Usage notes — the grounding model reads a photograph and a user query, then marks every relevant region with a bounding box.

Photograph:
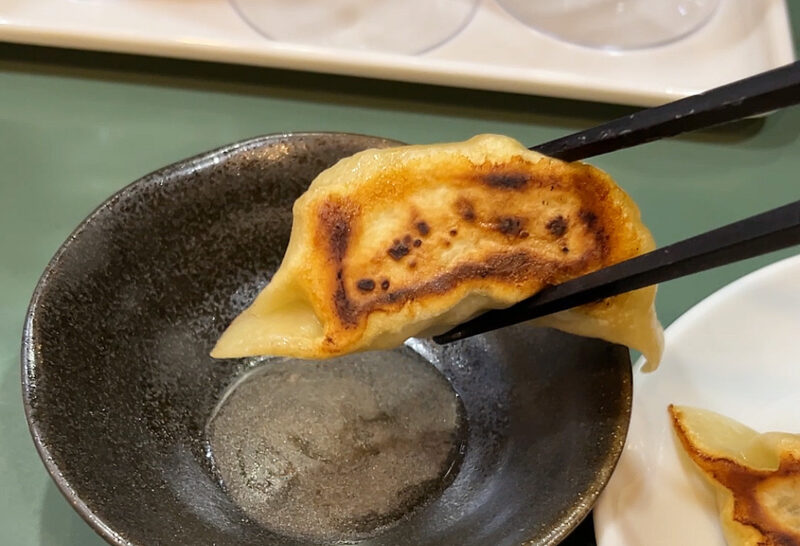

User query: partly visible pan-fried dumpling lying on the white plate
[669,405,800,546]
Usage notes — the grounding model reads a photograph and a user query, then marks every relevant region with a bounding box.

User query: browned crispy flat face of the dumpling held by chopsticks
[304,156,640,351]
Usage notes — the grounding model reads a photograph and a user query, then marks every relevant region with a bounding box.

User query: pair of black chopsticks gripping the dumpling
[433,61,800,343]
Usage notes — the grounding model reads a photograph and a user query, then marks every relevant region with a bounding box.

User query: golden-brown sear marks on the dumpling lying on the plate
[669,404,800,546]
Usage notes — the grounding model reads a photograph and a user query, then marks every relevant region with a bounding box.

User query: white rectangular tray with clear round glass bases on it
[0,0,794,106]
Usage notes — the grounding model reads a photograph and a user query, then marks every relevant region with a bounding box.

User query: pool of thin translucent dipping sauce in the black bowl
[207,350,466,541]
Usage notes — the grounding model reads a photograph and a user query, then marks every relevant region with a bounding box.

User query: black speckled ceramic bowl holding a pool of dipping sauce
[22,134,631,546]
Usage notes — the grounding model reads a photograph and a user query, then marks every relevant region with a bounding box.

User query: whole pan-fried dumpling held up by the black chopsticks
[211,135,663,367]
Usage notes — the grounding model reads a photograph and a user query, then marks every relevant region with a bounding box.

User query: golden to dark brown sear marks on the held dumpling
[317,156,627,329]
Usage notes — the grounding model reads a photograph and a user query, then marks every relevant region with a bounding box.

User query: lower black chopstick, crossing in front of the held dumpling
[433,201,800,343]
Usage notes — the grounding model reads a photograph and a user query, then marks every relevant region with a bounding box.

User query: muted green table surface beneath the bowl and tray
[0,7,800,546]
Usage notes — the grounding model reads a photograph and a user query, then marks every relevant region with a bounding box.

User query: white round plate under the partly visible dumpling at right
[594,255,800,546]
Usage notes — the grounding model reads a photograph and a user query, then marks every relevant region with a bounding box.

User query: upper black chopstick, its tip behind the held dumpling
[531,61,800,161]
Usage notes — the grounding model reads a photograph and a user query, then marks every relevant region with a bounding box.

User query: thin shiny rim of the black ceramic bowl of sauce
[20,131,633,546]
